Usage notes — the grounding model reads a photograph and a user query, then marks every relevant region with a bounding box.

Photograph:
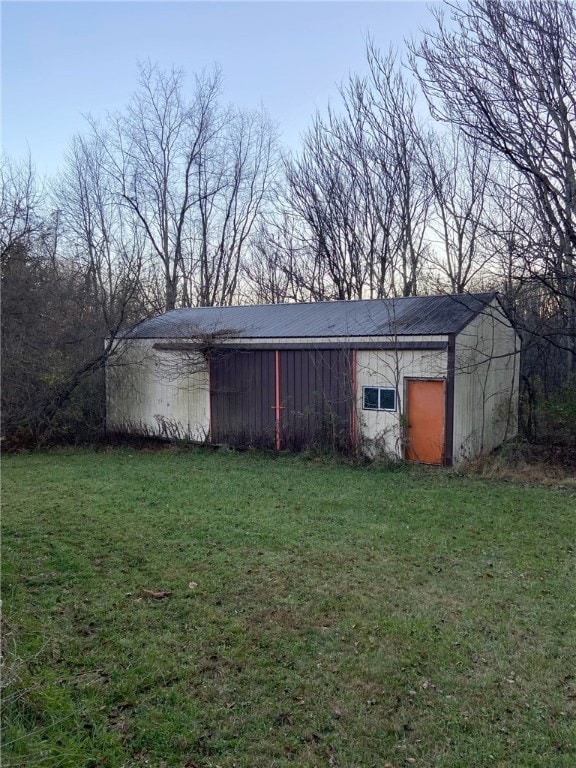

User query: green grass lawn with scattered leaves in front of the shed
[2,449,576,768]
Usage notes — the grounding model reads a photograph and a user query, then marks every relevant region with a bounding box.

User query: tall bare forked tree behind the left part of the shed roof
[103,64,222,310]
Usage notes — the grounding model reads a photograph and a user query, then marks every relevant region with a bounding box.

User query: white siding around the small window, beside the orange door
[356,346,447,459]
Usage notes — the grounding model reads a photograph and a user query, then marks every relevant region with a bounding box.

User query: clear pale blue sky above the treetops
[1,0,433,173]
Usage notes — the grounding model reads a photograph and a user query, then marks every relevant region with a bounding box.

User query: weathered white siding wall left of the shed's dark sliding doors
[106,340,210,441]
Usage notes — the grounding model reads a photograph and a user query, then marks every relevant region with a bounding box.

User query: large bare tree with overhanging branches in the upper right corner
[413,0,576,372]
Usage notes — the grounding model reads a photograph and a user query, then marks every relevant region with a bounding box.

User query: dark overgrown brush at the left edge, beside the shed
[1,247,106,450]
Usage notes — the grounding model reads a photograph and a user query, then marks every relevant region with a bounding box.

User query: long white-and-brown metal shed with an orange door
[107,293,519,465]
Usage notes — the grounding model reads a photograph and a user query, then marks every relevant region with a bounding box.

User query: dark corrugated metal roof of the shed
[127,293,496,339]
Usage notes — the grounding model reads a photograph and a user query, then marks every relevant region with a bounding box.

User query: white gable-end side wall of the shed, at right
[453,303,520,464]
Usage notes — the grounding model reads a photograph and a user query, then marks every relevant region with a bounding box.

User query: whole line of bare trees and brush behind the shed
[0,0,576,444]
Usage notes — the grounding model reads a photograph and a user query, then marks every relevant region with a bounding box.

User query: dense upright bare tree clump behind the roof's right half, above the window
[286,43,431,299]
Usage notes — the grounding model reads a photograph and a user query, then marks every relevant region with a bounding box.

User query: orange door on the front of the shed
[406,379,444,464]
